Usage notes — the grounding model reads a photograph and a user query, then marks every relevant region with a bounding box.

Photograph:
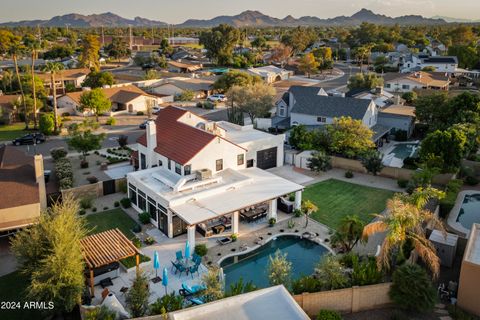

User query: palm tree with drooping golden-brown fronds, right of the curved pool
[363,192,445,277]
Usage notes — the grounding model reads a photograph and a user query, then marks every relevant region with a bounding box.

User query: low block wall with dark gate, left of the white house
[62,178,127,199]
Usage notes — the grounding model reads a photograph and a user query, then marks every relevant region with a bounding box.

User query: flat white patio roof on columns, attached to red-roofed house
[170,168,304,224]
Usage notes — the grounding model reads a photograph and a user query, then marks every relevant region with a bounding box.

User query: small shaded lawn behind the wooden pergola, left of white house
[85,208,137,239]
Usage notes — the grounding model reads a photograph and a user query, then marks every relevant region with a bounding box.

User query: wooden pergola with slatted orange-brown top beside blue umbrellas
[80,228,140,296]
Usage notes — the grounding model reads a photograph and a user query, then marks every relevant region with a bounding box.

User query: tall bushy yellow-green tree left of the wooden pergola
[12,195,86,312]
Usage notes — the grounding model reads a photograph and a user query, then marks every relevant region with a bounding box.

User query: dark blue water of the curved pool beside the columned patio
[221,236,329,291]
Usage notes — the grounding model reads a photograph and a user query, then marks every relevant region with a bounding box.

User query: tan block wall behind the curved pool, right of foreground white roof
[293,283,392,317]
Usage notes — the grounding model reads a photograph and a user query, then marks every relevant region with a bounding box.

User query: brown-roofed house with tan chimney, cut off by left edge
[0,145,47,232]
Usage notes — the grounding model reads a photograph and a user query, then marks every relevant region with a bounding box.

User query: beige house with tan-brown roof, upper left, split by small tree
[57,85,160,115]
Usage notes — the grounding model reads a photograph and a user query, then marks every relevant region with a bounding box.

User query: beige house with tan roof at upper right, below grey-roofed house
[383,71,450,92]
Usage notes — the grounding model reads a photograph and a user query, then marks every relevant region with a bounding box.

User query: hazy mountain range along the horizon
[0,9,447,28]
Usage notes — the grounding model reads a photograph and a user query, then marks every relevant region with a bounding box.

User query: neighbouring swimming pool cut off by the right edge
[448,190,480,237]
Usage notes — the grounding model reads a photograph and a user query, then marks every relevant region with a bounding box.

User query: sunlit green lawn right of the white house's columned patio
[302,179,394,229]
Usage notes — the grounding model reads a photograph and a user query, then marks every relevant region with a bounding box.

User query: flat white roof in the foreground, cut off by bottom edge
[169,286,310,320]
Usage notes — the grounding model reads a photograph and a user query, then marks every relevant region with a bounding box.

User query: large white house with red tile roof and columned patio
[127,107,303,246]
